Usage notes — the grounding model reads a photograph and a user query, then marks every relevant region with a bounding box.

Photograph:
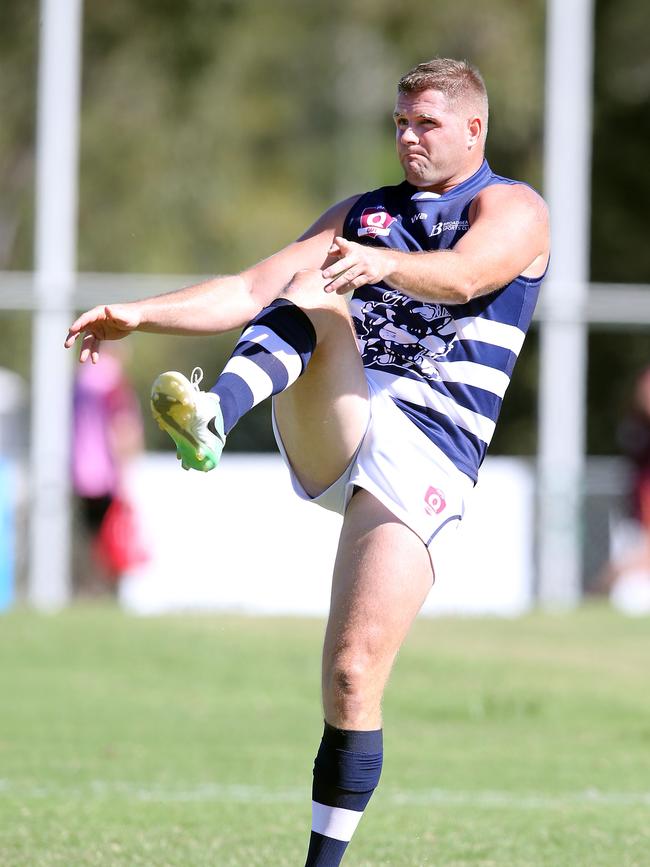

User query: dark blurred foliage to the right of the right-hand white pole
[587,0,650,454]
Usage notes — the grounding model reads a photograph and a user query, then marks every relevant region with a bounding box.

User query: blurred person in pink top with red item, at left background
[72,344,145,593]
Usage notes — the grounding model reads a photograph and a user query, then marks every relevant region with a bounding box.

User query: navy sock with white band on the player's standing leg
[305,723,383,867]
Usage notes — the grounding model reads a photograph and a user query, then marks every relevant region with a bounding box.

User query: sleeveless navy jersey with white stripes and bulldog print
[343,161,542,481]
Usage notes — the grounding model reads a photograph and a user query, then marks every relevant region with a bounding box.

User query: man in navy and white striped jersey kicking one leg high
[66,59,549,867]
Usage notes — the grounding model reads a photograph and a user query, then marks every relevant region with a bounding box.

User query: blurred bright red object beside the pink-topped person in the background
[95,497,149,581]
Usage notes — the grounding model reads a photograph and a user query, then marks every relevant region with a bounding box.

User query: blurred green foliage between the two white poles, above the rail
[79,0,543,273]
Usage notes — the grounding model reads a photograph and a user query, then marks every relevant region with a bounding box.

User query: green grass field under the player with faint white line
[0,607,650,867]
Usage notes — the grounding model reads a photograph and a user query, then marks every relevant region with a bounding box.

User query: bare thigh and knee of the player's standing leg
[323,490,433,730]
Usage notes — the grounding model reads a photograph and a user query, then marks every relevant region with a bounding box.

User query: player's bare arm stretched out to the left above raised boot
[65,197,356,363]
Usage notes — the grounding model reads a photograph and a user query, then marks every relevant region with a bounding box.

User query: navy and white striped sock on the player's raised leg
[211,298,316,433]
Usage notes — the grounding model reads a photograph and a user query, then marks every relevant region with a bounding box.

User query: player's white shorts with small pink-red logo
[273,371,474,562]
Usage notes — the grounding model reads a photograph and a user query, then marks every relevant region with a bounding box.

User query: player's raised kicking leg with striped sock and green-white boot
[151,271,369,482]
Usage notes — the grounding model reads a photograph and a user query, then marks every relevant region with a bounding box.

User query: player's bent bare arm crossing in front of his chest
[323,184,549,304]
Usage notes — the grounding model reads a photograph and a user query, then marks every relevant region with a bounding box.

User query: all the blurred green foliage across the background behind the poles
[0,0,650,453]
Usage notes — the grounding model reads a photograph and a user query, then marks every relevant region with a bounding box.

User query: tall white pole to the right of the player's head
[538,0,593,608]
